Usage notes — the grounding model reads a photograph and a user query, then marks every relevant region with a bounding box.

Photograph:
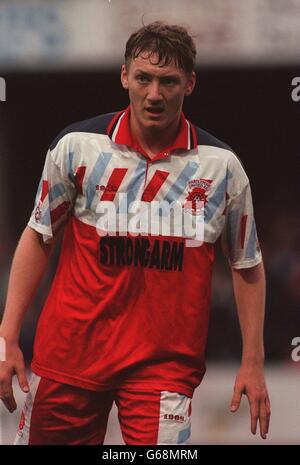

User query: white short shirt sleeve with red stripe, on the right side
[221,158,262,269]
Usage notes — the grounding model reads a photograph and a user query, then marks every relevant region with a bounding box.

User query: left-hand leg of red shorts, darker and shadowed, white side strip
[15,374,113,445]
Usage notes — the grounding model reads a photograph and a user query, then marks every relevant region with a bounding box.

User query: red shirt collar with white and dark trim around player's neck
[107,105,197,160]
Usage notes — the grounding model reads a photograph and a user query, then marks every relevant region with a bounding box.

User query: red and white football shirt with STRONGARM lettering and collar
[28,107,261,396]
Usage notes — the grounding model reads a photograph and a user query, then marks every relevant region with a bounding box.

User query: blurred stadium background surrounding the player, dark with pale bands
[0,0,300,444]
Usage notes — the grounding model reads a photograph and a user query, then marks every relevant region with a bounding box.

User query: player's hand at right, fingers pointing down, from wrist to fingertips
[230,365,271,439]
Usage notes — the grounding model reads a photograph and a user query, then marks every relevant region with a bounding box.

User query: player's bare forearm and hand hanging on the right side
[230,263,271,439]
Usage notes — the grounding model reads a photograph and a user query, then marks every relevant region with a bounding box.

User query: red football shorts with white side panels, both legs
[15,374,192,445]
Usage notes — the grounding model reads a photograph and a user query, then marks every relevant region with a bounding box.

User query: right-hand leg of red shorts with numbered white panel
[115,389,192,445]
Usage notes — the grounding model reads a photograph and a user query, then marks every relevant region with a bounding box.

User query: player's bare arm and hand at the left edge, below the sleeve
[0,226,53,412]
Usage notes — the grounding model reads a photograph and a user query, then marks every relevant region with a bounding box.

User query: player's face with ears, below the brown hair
[121,52,196,132]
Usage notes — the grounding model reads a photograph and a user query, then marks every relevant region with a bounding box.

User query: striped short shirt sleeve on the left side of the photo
[28,143,76,243]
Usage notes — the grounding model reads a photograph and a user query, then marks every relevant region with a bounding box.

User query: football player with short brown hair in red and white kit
[0,22,270,444]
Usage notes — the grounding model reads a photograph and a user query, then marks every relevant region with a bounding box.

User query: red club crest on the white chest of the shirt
[183,179,212,215]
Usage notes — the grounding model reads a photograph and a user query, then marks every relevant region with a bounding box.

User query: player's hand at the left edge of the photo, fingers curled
[0,336,29,413]
